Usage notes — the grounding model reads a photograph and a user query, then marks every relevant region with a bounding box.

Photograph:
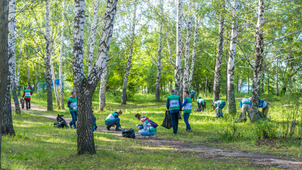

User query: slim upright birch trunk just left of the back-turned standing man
[155,0,164,102]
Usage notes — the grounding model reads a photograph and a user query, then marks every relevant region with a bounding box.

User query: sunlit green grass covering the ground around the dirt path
[2,91,302,169]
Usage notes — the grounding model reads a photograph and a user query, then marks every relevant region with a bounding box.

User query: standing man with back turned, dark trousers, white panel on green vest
[167,90,181,134]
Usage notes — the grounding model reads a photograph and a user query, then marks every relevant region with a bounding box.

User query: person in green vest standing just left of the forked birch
[67,91,78,129]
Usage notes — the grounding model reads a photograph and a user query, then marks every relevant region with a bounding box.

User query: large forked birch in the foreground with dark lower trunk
[72,0,118,154]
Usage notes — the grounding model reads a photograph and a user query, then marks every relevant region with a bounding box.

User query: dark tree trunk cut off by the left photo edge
[0,0,9,169]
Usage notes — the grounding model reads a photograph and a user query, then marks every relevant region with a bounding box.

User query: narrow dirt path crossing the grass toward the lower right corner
[20,103,302,169]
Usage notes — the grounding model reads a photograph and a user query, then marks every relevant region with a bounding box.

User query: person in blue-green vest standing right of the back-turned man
[181,91,192,132]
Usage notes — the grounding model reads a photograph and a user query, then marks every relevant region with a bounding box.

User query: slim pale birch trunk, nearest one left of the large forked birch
[59,0,65,109]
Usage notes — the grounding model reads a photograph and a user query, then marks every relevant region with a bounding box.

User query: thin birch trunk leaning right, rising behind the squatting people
[122,0,137,104]
